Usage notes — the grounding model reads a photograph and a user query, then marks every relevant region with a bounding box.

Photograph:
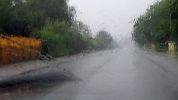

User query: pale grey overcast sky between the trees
[70,0,156,38]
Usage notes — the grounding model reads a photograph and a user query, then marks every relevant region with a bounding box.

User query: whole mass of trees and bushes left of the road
[0,0,114,57]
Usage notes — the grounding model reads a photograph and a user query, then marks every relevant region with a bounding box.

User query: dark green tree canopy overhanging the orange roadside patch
[0,0,75,35]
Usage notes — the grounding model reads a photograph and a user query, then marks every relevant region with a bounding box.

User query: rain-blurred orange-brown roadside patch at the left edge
[0,36,42,64]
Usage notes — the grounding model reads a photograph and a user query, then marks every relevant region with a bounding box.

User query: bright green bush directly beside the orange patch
[33,21,88,56]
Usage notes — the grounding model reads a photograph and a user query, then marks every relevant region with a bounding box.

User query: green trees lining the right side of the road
[133,0,178,51]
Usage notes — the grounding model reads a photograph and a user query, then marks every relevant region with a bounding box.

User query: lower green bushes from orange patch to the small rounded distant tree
[33,21,113,57]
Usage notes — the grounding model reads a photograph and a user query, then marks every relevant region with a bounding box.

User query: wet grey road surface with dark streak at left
[0,41,178,100]
